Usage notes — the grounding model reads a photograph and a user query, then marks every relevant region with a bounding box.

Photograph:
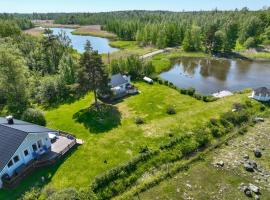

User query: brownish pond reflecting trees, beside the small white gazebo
[160,58,270,95]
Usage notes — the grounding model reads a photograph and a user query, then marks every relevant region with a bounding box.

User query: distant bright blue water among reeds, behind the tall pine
[50,28,119,54]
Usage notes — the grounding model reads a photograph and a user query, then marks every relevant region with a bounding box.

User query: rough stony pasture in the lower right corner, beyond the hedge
[139,119,270,200]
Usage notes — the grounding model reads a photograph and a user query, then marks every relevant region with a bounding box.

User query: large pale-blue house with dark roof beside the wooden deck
[0,117,58,188]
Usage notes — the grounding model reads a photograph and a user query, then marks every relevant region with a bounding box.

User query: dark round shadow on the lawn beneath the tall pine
[73,104,122,133]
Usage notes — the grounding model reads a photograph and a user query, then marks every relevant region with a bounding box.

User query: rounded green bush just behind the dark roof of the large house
[22,108,46,126]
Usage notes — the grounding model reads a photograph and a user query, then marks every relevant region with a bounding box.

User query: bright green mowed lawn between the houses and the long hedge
[0,82,248,199]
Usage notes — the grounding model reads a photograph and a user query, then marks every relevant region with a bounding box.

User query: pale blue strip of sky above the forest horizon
[0,0,270,13]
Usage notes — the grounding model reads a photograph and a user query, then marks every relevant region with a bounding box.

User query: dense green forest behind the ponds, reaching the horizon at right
[50,8,270,53]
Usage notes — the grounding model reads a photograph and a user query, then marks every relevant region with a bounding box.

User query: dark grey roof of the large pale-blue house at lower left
[0,117,57,172]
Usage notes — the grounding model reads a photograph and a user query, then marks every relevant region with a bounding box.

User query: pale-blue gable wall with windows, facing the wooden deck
[0,133,51,188]
